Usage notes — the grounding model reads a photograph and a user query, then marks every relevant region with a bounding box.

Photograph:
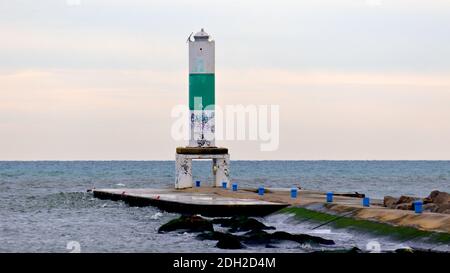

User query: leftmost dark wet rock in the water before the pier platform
[158,215,214,233]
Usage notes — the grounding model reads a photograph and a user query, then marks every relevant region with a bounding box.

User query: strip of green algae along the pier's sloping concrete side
[279,207,450,243]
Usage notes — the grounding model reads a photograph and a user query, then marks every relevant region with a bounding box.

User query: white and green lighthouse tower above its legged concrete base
[188,28,215,147]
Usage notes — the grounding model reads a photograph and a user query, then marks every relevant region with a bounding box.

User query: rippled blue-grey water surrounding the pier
[0,161,450,252]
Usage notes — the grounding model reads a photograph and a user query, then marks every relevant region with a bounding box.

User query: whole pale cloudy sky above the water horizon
[0,0,450,160]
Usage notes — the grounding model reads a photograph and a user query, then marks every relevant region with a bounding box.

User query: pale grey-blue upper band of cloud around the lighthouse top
[0,0,450,73]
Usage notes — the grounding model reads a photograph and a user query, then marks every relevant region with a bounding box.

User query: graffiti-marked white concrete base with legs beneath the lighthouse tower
[175,147,230,189]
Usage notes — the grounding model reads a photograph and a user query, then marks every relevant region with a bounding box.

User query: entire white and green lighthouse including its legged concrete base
[175,29,230,189]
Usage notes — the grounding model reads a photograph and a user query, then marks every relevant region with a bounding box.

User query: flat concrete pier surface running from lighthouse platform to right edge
[92,187,450,233]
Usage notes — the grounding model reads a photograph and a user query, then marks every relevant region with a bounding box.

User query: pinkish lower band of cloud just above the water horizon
[0,66,450,159]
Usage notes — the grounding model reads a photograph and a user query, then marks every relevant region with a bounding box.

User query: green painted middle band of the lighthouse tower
[189,73,215,110]
